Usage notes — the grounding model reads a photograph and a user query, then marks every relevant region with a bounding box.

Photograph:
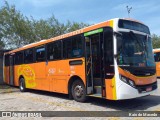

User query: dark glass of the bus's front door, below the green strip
[86,33,102,86]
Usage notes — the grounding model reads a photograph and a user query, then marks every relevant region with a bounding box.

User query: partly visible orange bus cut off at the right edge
[153,48,160,77]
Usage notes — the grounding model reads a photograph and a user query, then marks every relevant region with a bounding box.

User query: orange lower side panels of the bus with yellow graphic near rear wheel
[9,58,86,94]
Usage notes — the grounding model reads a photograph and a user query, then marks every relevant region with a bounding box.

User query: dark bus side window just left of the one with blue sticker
[24,49,33,63]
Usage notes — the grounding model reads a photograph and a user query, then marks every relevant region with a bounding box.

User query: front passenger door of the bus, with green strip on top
[84,28,104,97]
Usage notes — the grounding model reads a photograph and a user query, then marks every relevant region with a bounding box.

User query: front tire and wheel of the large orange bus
[71,80,87,102]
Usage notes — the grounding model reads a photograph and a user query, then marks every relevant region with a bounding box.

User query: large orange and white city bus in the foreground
[4,18,157,102]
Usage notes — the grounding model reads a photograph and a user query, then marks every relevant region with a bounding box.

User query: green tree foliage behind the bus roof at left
[0,2,88,49]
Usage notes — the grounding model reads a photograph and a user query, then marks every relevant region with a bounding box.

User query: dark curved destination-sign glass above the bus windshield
[118,20,150,34]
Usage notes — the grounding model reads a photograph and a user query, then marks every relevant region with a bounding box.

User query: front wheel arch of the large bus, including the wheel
[68,76,87,102]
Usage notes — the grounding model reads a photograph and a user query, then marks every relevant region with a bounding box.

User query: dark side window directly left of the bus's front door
[63,36,83,58]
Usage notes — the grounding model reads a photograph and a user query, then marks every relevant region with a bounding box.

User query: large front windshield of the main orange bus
[117,31,155,67]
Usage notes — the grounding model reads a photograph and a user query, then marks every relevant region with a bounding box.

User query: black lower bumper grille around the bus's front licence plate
[136,82,157,93]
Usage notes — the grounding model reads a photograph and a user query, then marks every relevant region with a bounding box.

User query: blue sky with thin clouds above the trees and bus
[0,0,160,36]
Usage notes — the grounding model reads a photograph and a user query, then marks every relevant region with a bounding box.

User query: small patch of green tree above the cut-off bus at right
[152,34,160,48]
